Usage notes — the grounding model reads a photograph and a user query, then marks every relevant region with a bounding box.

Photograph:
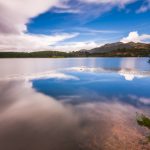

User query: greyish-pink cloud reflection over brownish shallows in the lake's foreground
[0,82,149,150]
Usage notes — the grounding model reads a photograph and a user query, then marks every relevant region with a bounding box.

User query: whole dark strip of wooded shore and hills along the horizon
[0,42,150,58]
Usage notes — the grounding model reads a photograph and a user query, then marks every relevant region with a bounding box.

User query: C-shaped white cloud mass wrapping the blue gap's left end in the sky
[0,0,78,51]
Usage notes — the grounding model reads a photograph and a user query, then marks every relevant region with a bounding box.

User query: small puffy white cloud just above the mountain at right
[121,31,150,43]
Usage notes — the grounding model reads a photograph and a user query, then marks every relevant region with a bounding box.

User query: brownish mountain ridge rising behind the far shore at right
[88,42,150,54]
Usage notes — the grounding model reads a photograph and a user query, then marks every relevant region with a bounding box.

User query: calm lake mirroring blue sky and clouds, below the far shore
[0,58,150,150]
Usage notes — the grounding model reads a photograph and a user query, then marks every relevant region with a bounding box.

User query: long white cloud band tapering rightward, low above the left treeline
[0,33,78,51]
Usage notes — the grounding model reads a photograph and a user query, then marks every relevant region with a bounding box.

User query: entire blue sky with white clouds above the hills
[0,0,150,52]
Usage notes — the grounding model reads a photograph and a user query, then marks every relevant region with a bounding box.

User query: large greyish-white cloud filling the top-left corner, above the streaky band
[0,0,65,34]
